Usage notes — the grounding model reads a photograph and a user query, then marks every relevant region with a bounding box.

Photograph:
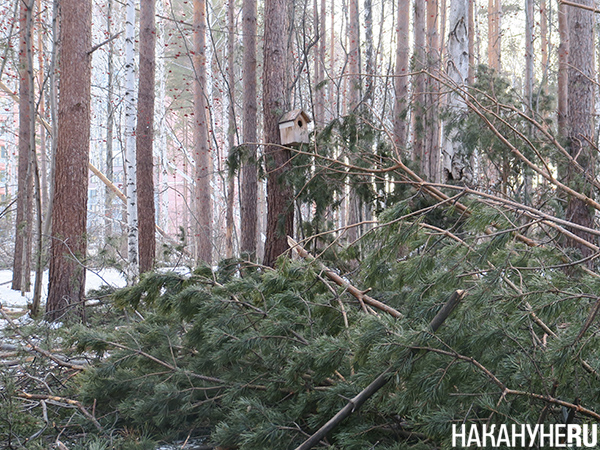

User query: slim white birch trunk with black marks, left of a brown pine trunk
[124,0,139,282]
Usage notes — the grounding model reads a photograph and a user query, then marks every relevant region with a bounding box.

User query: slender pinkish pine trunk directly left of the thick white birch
[422,0,441,182]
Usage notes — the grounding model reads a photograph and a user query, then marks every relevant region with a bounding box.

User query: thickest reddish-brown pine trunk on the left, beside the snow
[46,0,92,320]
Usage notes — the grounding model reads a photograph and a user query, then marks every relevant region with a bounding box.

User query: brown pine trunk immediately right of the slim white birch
[135,0,156,273]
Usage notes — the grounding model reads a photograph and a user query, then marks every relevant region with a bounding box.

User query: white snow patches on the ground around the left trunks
[0,269,126,310]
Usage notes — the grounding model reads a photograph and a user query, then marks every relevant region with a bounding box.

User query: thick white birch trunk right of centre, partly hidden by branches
[442,0,473,183]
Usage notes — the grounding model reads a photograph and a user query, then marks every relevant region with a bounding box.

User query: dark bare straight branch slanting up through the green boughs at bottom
[288,288,466,450]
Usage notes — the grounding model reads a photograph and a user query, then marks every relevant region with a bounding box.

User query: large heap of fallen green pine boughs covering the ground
[64,202,600,450]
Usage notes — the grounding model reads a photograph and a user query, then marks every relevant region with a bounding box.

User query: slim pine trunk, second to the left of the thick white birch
[412,1,426,166]
